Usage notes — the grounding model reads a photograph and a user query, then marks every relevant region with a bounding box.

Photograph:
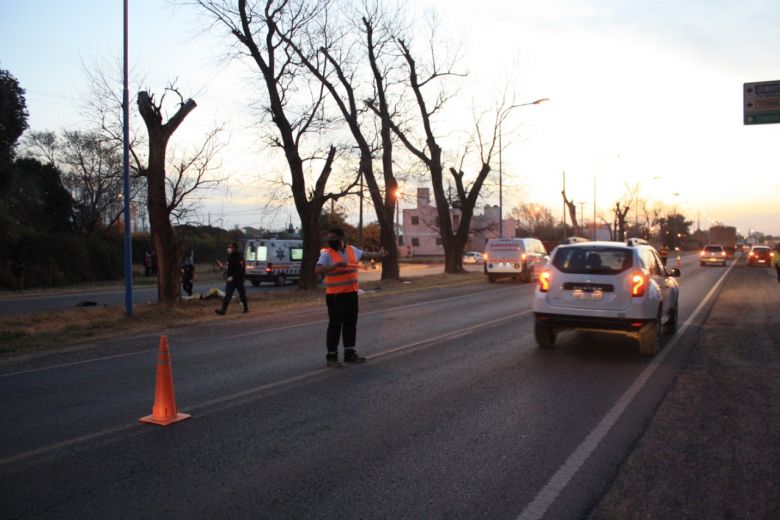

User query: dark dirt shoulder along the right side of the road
[591,264,780,519]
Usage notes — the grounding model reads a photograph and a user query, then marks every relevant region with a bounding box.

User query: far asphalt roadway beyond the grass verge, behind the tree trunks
[0,264,450,315]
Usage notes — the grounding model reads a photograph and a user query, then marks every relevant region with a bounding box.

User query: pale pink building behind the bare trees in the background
[399,188,517,256]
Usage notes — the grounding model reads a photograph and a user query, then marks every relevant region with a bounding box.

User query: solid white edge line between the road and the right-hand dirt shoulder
[518,263,735,520]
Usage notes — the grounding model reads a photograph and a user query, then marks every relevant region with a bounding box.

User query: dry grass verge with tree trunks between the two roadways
[0,272,484,358]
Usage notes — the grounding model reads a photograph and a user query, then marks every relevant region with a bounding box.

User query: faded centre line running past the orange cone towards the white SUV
[0,310,531,467]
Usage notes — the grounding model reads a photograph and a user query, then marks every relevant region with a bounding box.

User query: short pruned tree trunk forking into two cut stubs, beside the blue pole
[138,89,197,304]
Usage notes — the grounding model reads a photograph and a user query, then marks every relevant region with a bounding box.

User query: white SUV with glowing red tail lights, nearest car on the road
[533,238,680,355]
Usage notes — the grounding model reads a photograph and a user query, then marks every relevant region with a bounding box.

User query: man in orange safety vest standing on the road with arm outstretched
[314,228,387,368]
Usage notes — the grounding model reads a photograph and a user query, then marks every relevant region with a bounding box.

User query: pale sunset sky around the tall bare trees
[0,0,780,235]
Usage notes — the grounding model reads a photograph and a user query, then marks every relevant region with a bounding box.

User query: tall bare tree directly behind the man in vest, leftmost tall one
[196,0,359,289]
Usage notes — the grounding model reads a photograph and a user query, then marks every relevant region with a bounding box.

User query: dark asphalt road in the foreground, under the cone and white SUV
[0,257,729,519]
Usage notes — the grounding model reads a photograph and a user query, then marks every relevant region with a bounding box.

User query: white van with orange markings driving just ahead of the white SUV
[485,238,549,283]
